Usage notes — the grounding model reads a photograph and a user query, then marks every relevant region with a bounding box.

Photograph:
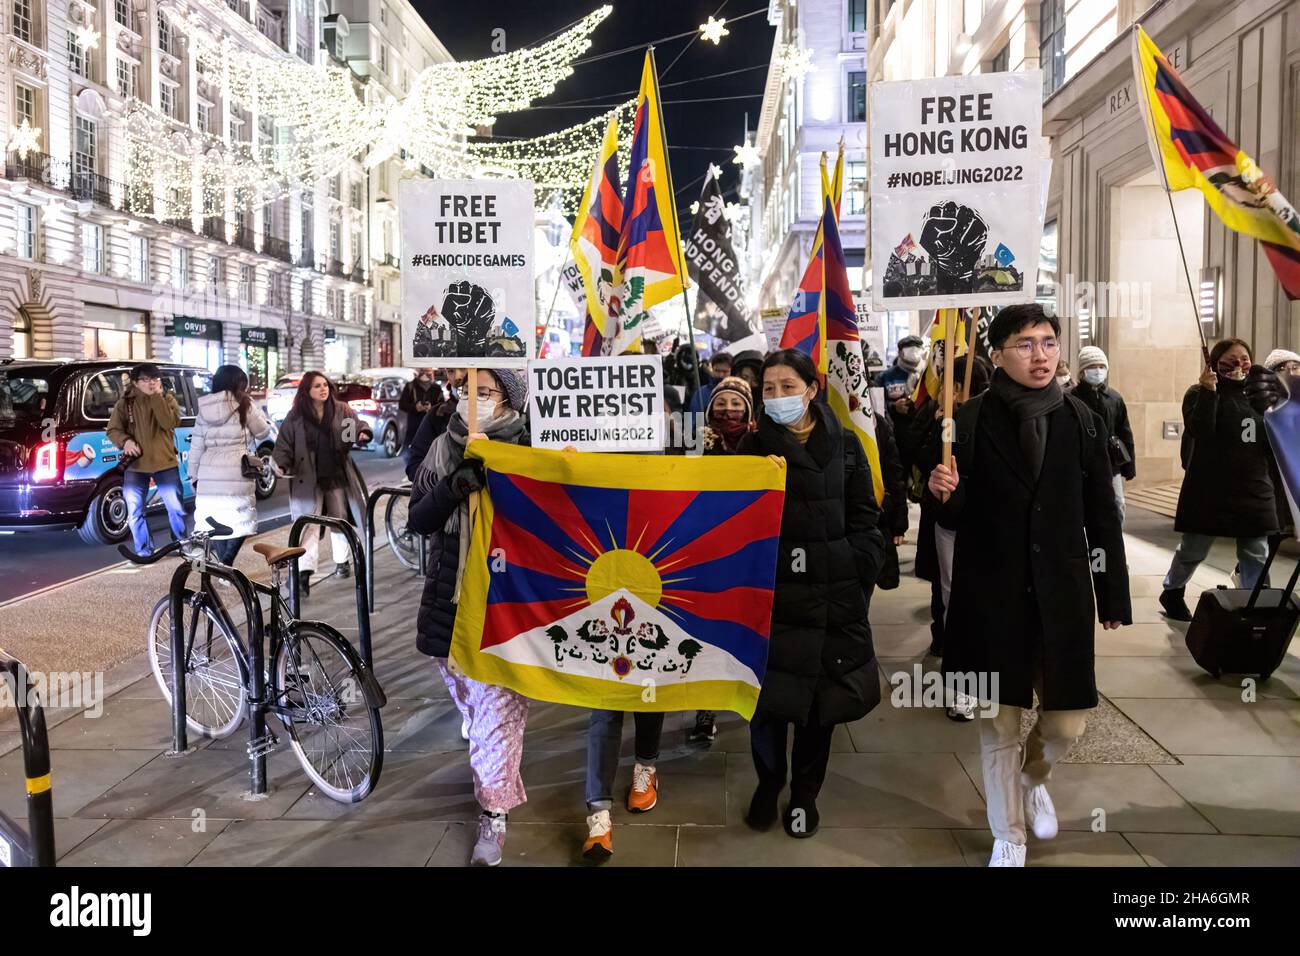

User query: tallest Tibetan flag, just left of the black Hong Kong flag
[610,49,686,355]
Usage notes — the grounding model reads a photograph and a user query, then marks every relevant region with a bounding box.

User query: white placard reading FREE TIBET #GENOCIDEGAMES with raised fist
[398,179,537,368]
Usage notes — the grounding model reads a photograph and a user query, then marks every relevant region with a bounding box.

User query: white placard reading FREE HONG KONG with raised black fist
[871,70,1043,311]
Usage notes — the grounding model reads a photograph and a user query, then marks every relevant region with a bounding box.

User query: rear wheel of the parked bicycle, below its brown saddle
[272,623,384,804]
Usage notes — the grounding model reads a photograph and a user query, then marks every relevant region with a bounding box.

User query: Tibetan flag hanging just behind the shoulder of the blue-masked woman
[820,184,885,505]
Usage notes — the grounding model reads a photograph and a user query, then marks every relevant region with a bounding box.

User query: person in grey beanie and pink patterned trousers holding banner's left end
[407,368,529,866]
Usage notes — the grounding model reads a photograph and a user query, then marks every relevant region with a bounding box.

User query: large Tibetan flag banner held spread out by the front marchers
[451,440,785,719]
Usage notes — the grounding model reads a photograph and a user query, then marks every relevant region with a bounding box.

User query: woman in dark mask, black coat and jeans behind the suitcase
[1160,338,1278,620]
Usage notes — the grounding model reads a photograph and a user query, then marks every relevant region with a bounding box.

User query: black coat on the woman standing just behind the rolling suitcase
[1174,378,1278,537]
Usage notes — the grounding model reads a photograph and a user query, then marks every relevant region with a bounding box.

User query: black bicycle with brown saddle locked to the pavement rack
[118,518,386,803]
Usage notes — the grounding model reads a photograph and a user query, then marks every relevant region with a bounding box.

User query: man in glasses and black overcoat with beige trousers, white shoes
[928,304,1132,866]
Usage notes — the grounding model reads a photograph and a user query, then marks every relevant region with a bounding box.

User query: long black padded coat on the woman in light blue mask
[740,402,884,726]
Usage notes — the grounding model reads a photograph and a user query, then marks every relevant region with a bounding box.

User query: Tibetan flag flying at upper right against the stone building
[1132,26,1300,299]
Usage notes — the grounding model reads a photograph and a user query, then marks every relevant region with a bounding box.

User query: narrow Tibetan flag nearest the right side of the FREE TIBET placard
[569,116,623,355]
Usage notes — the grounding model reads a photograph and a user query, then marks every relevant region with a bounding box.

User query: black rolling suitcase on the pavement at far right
[1187,537,1300,680]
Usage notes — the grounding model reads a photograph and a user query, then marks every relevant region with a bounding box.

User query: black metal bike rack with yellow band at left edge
[0,652,55,866]
